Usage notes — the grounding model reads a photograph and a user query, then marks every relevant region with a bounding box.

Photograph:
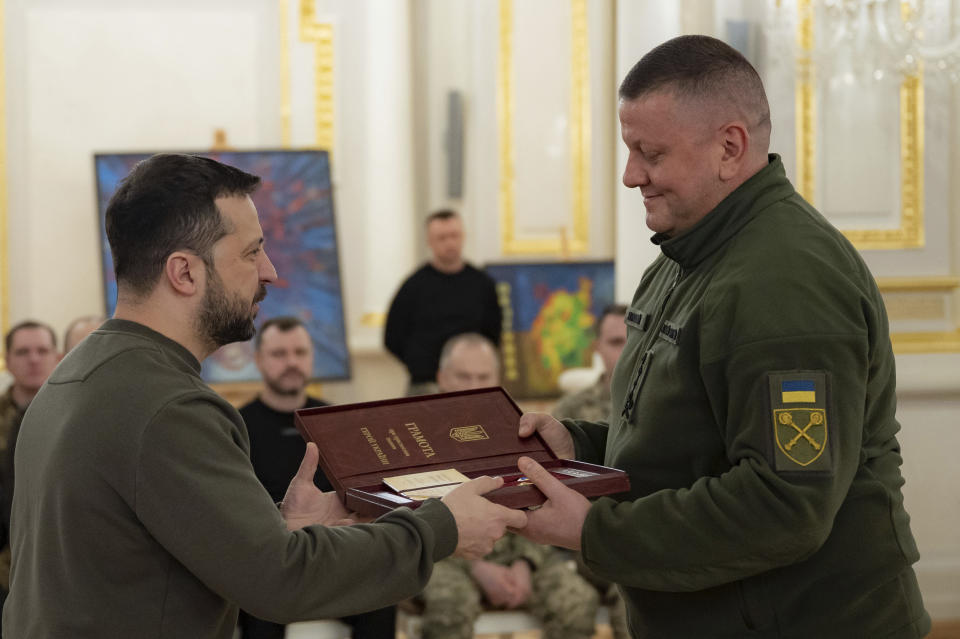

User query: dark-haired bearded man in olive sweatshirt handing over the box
[3,155,526,639]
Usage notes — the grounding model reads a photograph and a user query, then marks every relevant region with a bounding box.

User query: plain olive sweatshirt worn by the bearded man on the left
[3,320,457,639]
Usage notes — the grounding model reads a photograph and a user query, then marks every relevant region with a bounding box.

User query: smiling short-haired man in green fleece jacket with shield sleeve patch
[520,36,930,639]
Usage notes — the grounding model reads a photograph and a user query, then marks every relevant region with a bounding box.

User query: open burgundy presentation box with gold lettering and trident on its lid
[295,387,630,515]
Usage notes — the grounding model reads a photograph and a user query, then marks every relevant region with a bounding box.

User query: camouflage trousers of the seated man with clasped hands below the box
[418,534,599,639]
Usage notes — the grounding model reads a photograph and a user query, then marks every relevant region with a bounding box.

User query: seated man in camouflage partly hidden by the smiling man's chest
[551,304,630,639]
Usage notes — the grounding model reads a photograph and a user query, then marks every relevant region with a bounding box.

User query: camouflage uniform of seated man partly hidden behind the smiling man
[552,375,630,639]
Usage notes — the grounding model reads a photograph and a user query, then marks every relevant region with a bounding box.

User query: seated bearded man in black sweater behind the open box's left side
[239,317,396,639]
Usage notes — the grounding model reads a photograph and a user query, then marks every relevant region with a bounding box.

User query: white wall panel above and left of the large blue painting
[5,0,277,340]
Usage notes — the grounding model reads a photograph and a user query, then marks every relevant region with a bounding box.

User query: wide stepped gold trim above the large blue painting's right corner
[300,0,334,152]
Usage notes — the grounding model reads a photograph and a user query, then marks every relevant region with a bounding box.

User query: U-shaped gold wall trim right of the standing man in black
[497,0,590,256]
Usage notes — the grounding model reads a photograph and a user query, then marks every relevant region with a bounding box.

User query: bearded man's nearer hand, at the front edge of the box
[442,477,527,559]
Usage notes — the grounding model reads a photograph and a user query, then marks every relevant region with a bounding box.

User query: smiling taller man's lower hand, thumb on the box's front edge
[516,457,590,550]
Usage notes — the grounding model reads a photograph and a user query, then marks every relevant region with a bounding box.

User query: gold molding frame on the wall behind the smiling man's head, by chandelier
[795,0,924,250]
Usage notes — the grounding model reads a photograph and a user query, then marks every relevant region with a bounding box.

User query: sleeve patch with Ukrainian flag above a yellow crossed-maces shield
[769,371,833,473]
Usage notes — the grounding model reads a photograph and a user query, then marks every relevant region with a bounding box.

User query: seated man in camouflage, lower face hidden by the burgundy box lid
[420,333,598,639]
